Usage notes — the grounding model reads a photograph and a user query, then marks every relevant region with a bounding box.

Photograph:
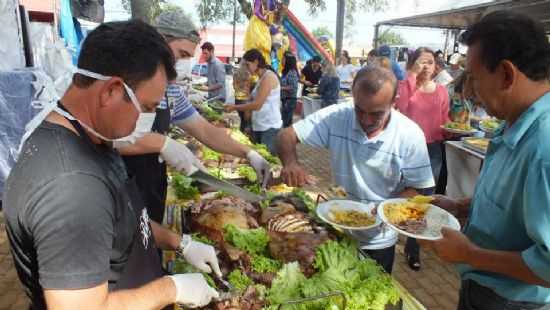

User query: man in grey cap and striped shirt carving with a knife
[115,11,270,223]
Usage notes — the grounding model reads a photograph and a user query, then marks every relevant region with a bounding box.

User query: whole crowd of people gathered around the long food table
[4,4,550,310]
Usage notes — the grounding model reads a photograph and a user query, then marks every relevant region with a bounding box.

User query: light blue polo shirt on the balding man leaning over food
[293,102,434,250]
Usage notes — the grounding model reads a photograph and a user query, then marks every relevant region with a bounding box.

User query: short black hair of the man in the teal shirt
[460,11,550,81]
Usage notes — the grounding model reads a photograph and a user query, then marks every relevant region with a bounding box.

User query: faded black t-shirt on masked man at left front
[4,122,136,309]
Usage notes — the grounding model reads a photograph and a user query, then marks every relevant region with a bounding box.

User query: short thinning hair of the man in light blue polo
[352,66,397,99]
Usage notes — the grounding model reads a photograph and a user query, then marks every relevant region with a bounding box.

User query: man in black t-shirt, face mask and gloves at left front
[4,21,219,310]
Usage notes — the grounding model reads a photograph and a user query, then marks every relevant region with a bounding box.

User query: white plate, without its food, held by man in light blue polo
[317,199,382,230]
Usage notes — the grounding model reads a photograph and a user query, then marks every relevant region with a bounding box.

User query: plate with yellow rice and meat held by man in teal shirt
[378,196,460,240]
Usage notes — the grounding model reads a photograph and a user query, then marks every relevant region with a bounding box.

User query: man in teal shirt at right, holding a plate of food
[423,11,550,310]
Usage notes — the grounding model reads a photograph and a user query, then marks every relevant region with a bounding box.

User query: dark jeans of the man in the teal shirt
[458,280,550,310]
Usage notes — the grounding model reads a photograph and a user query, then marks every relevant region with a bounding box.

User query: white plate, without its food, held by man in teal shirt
[378,198,460,240]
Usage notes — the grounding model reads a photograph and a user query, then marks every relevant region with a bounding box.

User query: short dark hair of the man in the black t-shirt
[73,20,177,89]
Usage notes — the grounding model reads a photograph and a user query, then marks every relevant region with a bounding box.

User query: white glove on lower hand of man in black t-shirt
[169,273,219,308]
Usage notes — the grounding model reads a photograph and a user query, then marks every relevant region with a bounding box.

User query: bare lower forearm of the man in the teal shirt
[465,247,550,287]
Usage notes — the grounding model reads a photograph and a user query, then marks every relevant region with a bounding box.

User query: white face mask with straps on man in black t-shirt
[54,69,156,143]
